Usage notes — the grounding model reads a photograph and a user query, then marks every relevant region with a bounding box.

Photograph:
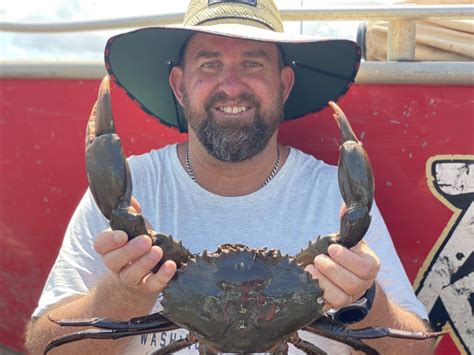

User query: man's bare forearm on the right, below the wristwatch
[352,284,434,355]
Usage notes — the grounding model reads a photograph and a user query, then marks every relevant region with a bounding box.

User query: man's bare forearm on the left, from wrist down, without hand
[26,274,156,354]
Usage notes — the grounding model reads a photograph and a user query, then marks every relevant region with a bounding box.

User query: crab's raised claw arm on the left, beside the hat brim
[86,76,192,271]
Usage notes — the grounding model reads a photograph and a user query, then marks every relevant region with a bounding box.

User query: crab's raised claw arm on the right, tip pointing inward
[295,102,374,266]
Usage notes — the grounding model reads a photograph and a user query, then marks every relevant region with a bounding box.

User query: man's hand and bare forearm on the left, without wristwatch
[27,198,176,354]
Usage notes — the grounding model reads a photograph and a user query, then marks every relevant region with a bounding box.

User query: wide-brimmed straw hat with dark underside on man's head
[105,0,361,132]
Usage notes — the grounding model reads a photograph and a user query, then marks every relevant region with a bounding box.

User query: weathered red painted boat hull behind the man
[0,80,474,354]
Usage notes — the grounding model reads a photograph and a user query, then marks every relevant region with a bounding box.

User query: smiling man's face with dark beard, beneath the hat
[170,34,293,162]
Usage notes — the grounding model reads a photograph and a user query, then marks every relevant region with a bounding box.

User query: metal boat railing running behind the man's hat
[0,4,474,85]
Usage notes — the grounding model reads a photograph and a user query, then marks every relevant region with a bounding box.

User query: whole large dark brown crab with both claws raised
[45,78,439,354]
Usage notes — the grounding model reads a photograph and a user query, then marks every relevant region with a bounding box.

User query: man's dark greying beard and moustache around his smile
[183,91,284,162]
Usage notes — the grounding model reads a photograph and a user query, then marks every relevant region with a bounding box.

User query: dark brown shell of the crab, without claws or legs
[162,245,324,353]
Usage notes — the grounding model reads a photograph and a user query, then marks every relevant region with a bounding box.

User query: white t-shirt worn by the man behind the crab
[33,144,427,354]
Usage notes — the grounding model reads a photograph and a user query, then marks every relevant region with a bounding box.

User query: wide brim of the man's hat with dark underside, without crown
[105,26,361,132]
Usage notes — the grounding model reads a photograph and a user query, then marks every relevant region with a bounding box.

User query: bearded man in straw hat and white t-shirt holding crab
[27,0,432,354]
